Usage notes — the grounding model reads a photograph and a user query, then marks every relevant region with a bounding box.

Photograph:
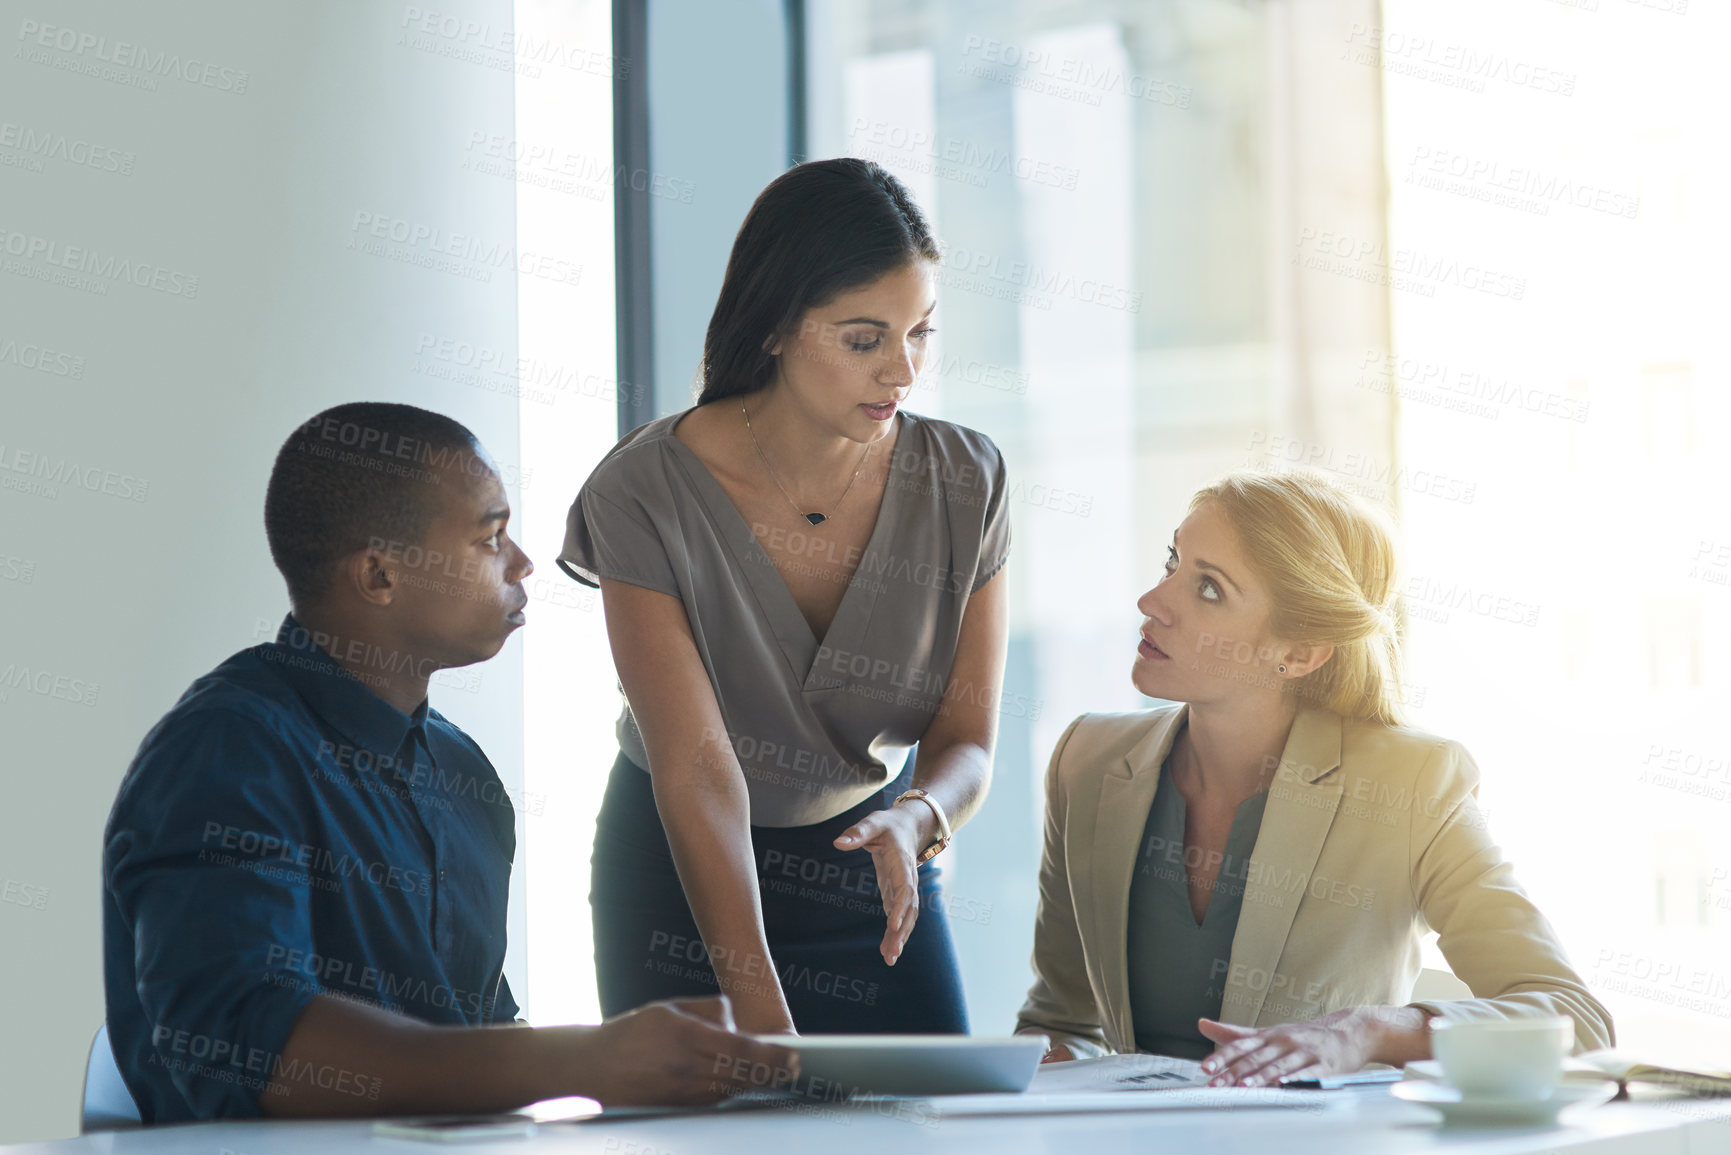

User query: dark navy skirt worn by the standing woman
[589,753,968,1034]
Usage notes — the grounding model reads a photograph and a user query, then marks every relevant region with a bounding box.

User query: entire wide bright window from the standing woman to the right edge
[810,0,1731,1061]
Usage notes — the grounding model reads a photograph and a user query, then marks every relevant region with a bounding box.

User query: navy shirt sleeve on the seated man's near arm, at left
[104,710,320,1119]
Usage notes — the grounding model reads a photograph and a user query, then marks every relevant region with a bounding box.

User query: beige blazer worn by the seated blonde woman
[1016,705,1613,1058]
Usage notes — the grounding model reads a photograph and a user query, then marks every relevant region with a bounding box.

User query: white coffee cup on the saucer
[1430,1015,1575,1100]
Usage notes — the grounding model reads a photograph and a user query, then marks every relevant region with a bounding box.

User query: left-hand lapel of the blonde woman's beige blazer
[1071,707,1189,1051]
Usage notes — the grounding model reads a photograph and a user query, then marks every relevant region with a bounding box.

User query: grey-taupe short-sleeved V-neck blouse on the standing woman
[559,410,1009,826]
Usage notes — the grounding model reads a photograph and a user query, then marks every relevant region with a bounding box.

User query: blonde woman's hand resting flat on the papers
[1196,1006,1407,1087]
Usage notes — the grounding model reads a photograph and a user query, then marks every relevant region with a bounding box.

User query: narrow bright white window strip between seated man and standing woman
[512,0,630,1025]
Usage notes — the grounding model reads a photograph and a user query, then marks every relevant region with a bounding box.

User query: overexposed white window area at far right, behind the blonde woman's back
[1384,0,1731,1061]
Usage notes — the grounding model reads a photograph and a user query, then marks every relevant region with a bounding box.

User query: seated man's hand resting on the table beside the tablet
[569,996,800,1107]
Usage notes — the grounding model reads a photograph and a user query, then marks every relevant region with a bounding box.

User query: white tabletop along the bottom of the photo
[10,1087,1731,1155]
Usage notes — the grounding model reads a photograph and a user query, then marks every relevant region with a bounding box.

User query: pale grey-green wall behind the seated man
[0,0,526,1141]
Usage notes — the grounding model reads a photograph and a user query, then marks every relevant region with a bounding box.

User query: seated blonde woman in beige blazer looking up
[1016,473,1613,1086]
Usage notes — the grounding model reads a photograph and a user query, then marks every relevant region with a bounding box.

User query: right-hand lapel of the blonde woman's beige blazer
[1220,710,1342,1027]
